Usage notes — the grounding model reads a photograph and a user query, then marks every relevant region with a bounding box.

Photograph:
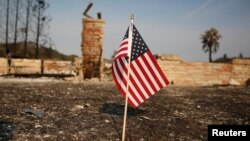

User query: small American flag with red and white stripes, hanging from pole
[112,25,169,108]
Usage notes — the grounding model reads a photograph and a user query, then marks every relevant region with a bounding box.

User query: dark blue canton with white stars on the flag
[131,26,149,61]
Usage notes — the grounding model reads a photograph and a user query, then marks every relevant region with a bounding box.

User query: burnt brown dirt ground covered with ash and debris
[0,81,250,141]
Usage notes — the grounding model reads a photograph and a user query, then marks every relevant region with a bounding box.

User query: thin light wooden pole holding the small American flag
[122,15,134,141]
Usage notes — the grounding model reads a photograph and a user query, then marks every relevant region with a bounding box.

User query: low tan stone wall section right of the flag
[157,55,250,86]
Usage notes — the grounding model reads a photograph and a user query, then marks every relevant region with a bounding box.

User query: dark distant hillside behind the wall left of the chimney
[0,42,78,61]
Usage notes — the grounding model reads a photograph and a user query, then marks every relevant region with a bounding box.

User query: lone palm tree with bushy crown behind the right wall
[201,28,222,62]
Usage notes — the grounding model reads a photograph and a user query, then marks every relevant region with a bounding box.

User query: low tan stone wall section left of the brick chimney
[0,58,76,75]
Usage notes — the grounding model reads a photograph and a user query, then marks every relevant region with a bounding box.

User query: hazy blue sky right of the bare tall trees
[48,0,250,61]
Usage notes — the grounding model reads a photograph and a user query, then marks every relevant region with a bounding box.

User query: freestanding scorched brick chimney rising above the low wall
[81,18,105,79]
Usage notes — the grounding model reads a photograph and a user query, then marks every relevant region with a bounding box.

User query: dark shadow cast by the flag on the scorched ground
[100,103,145,116]
